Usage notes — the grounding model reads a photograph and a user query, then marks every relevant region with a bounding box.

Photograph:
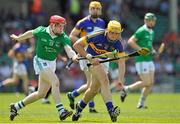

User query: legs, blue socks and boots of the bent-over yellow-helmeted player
[72,65,120,122]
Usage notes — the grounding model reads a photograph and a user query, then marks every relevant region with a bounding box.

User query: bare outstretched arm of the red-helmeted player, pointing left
[10,30,33,42]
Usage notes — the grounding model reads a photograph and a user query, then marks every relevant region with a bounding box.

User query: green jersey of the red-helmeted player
[33,26,71,61]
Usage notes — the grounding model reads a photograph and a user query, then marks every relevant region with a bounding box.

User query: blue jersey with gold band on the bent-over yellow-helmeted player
[86,30,124,56]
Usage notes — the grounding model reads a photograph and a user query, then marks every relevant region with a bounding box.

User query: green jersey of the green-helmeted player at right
[133,25,154,62]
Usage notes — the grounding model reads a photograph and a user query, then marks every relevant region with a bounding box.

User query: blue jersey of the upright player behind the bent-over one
[75,16,105,37]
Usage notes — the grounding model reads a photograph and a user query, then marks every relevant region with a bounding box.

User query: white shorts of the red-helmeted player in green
[33,56,56,74]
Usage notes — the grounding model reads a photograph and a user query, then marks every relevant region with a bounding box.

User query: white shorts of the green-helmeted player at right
[136,61,155,74]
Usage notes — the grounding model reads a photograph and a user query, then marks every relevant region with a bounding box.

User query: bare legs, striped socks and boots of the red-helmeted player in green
[10,69,72,120]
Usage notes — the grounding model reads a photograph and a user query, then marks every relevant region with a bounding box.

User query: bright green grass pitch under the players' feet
[0,93,180,123]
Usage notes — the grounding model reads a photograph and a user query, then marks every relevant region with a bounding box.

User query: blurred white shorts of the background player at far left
[13,62,27,76]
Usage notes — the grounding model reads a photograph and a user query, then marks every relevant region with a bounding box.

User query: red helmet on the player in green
[49,15,66,24]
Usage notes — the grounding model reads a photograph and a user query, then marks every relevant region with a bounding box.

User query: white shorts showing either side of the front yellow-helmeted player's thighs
[79,60,109,73]
